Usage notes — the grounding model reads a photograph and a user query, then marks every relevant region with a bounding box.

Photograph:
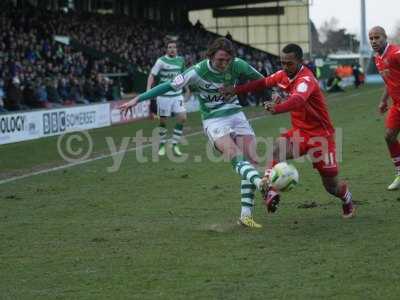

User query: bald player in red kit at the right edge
[369,26,400,190]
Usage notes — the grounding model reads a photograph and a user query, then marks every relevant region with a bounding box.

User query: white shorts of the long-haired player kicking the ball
[203,112,255,144]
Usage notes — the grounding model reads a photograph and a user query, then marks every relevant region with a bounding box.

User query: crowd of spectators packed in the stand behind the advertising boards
[0,2,274,113]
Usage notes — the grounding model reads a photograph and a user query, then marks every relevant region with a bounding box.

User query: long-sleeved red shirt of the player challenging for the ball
[235,66,335,136]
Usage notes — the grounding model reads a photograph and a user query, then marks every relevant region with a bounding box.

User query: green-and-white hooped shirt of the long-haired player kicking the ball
[171,58,263,119]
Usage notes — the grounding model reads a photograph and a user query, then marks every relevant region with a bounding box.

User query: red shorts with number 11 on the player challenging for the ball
[281,129,339,177]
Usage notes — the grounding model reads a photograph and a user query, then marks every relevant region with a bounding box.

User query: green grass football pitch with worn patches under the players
[0,86,400,299]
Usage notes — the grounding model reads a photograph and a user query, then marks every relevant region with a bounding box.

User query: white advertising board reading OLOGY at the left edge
[0,112,42,145]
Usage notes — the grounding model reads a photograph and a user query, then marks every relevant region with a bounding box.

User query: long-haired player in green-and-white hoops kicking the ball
[120,38,266,228]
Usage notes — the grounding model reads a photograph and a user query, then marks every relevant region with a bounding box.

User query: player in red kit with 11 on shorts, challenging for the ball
[223,44,355,218]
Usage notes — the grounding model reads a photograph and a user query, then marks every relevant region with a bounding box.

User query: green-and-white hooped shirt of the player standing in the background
[151,55,185,97]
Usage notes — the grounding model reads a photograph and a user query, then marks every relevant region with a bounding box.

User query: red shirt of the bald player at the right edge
[375,44,400,108]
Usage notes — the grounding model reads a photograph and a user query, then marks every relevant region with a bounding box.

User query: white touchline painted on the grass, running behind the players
[0,89,378,185]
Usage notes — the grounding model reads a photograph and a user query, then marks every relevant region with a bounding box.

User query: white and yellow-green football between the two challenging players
[270,162,299,192]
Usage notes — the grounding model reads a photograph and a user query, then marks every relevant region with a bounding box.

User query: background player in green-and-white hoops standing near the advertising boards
[147,41,190,156]
